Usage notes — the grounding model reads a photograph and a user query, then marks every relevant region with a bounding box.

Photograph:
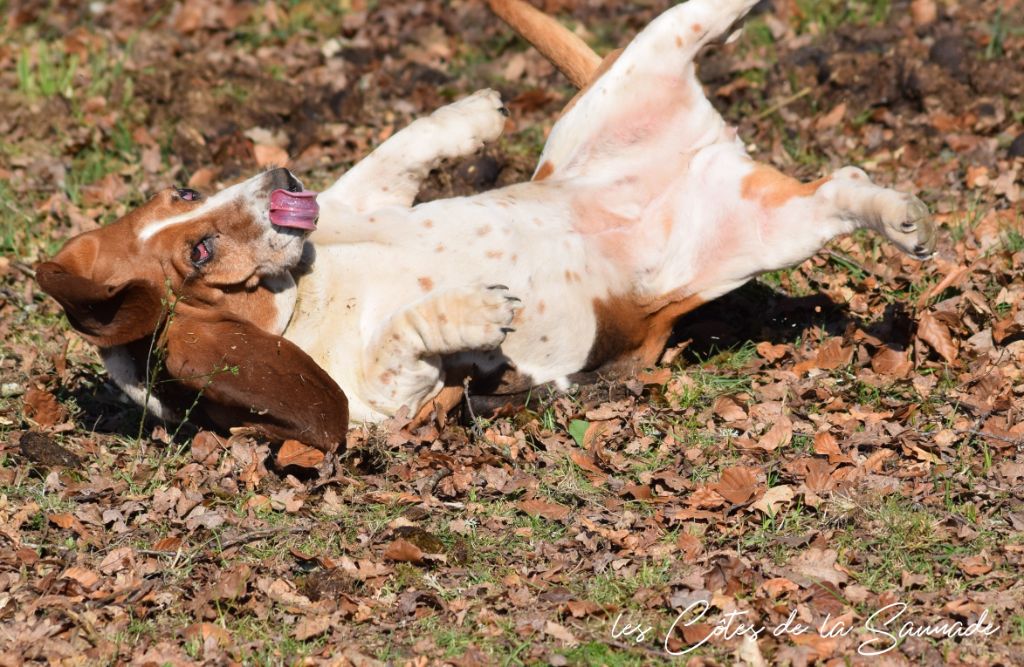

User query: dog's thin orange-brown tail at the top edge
[487,0,601,88]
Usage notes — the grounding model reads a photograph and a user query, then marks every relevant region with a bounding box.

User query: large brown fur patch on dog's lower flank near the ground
[584,295,703,375]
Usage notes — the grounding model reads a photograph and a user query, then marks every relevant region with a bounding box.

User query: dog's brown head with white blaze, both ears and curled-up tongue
[36,169,347,448]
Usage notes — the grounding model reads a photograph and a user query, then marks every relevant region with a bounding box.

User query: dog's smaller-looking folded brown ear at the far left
[36,261,164,347]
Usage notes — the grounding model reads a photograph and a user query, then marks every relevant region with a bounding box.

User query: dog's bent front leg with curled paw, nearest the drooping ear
[358,285,519,415]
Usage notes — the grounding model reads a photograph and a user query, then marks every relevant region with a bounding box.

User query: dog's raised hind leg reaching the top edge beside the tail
[535,0,757,179]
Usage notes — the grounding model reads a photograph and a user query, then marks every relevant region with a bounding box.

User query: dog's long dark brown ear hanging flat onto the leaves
[166,303,348,452]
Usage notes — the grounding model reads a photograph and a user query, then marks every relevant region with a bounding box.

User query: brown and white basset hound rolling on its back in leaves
[38,0,934,450]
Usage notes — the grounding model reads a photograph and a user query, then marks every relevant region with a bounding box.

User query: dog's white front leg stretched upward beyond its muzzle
[317,89,508,218]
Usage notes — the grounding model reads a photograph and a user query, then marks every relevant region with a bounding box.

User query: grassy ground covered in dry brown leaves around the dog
[0,0,1024,665]
